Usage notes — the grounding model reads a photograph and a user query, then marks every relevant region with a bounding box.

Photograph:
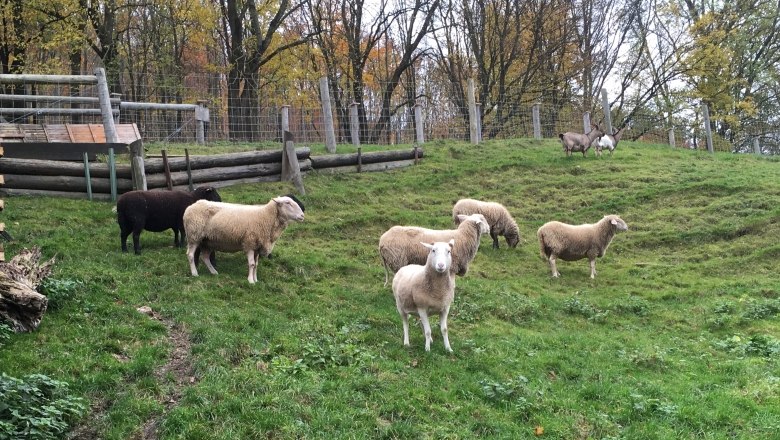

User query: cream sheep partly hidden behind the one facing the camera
[379,214,490,286]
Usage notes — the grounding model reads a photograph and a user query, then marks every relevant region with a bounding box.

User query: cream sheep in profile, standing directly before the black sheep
[184,196,304,284]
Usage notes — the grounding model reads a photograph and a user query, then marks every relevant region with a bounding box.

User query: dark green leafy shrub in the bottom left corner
[0,373,86,440]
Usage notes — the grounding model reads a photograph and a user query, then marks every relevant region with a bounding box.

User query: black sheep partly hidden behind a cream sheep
[116,186,222,254]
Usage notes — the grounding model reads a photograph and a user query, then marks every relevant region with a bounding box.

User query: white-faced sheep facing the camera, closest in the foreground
[393,240,455,352]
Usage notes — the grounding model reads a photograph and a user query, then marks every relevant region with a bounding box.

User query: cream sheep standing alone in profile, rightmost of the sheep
[536,215,628,278]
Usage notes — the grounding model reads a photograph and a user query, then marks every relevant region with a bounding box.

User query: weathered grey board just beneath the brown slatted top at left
[2,142,127,161]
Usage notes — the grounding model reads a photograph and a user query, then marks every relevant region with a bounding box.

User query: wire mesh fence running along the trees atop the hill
[0,74,768,151]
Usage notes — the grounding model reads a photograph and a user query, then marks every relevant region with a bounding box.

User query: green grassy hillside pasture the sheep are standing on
[0,140,780,439]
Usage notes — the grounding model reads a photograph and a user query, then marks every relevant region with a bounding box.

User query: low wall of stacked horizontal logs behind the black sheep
[0,147,423,200]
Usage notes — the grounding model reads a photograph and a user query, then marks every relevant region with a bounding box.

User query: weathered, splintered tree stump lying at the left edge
[0,247,54,333]
